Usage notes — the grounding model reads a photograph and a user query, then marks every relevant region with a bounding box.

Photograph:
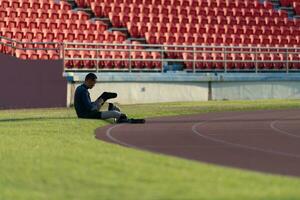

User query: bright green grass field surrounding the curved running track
[0,100,300,200]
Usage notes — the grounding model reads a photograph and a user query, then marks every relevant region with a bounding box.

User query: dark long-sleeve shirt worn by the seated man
[74,84,94,117]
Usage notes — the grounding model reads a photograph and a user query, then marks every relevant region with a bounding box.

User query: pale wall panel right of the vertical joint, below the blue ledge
[212,81,300,100]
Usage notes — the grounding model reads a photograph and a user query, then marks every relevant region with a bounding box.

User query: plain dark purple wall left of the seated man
[0,54,67,109]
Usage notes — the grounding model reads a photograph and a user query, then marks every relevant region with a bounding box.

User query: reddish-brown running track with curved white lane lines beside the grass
[96,109,300,176]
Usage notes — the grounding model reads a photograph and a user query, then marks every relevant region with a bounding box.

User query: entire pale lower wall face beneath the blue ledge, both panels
[68,81,300,105]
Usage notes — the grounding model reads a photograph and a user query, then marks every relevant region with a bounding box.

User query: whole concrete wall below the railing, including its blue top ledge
[65,72,300,104]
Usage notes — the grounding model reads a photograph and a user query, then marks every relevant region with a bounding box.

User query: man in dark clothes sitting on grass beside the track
[74,73,128,123]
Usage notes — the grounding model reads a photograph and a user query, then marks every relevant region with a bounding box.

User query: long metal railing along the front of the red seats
[0,36,300,73]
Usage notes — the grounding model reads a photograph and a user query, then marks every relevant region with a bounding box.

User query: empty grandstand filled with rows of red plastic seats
[0,0,300,72]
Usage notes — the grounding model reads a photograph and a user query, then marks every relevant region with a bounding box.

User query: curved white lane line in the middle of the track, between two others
[192,115,300,159]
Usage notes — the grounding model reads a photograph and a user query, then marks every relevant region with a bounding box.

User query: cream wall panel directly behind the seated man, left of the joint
[69,82,208,104]
